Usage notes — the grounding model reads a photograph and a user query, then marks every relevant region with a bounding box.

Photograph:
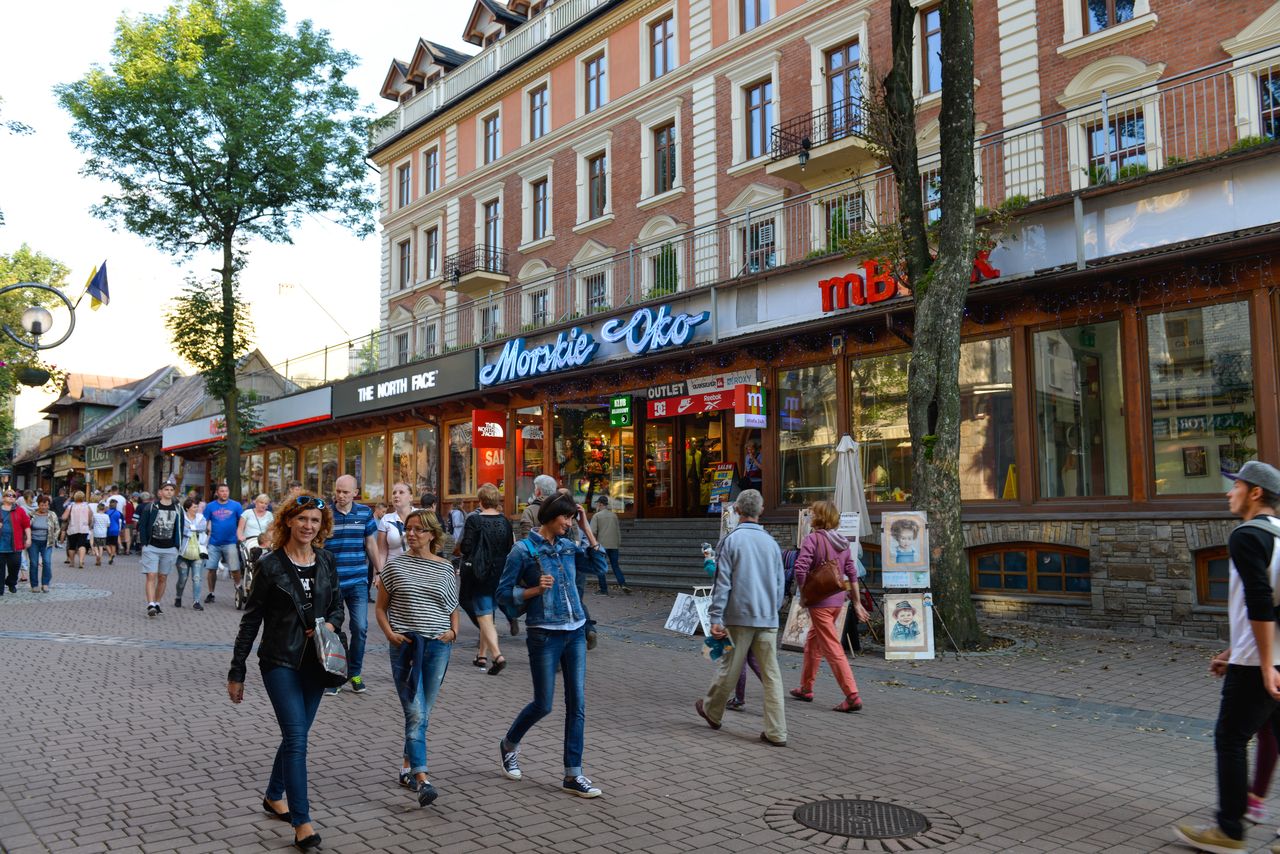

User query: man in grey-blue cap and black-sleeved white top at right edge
[1174,460,1280,854]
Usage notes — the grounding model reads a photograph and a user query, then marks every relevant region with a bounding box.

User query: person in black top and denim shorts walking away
[461,484,516,676]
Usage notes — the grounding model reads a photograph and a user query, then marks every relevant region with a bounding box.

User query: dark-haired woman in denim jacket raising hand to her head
[498,495,608,798]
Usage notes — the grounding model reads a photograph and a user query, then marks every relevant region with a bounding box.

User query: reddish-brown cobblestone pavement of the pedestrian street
[0,556,1274,854]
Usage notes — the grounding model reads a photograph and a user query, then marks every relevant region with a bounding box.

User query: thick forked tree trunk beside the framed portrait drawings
[881,0,982,647]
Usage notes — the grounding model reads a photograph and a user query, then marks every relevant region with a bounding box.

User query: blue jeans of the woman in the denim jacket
[507,626,586,777]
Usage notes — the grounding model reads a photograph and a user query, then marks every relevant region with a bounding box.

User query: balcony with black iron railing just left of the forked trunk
[764,101,879,188]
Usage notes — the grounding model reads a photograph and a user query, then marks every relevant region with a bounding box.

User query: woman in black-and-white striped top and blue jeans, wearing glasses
[376,510,458,807]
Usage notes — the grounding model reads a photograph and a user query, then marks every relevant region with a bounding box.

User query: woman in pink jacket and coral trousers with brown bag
[791,501,867,712]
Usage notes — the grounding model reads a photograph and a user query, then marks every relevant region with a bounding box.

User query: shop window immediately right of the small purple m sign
[774,365,840,504]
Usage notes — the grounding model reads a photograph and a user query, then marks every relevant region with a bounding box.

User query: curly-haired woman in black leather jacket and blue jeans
[227,494,346,850]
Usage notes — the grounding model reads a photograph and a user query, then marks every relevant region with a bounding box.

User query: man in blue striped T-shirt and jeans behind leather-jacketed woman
[324,475,383,695]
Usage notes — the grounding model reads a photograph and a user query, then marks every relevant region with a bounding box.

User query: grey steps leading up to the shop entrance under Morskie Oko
[618,519,719,593]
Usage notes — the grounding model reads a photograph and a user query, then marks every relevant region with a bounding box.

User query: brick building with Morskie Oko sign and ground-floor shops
[192,0,1280,635]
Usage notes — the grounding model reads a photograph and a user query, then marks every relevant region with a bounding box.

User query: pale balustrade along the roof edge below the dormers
[369,0,622,149]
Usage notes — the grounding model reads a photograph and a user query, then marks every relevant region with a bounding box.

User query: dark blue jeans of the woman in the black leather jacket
[262,656,324,827]
